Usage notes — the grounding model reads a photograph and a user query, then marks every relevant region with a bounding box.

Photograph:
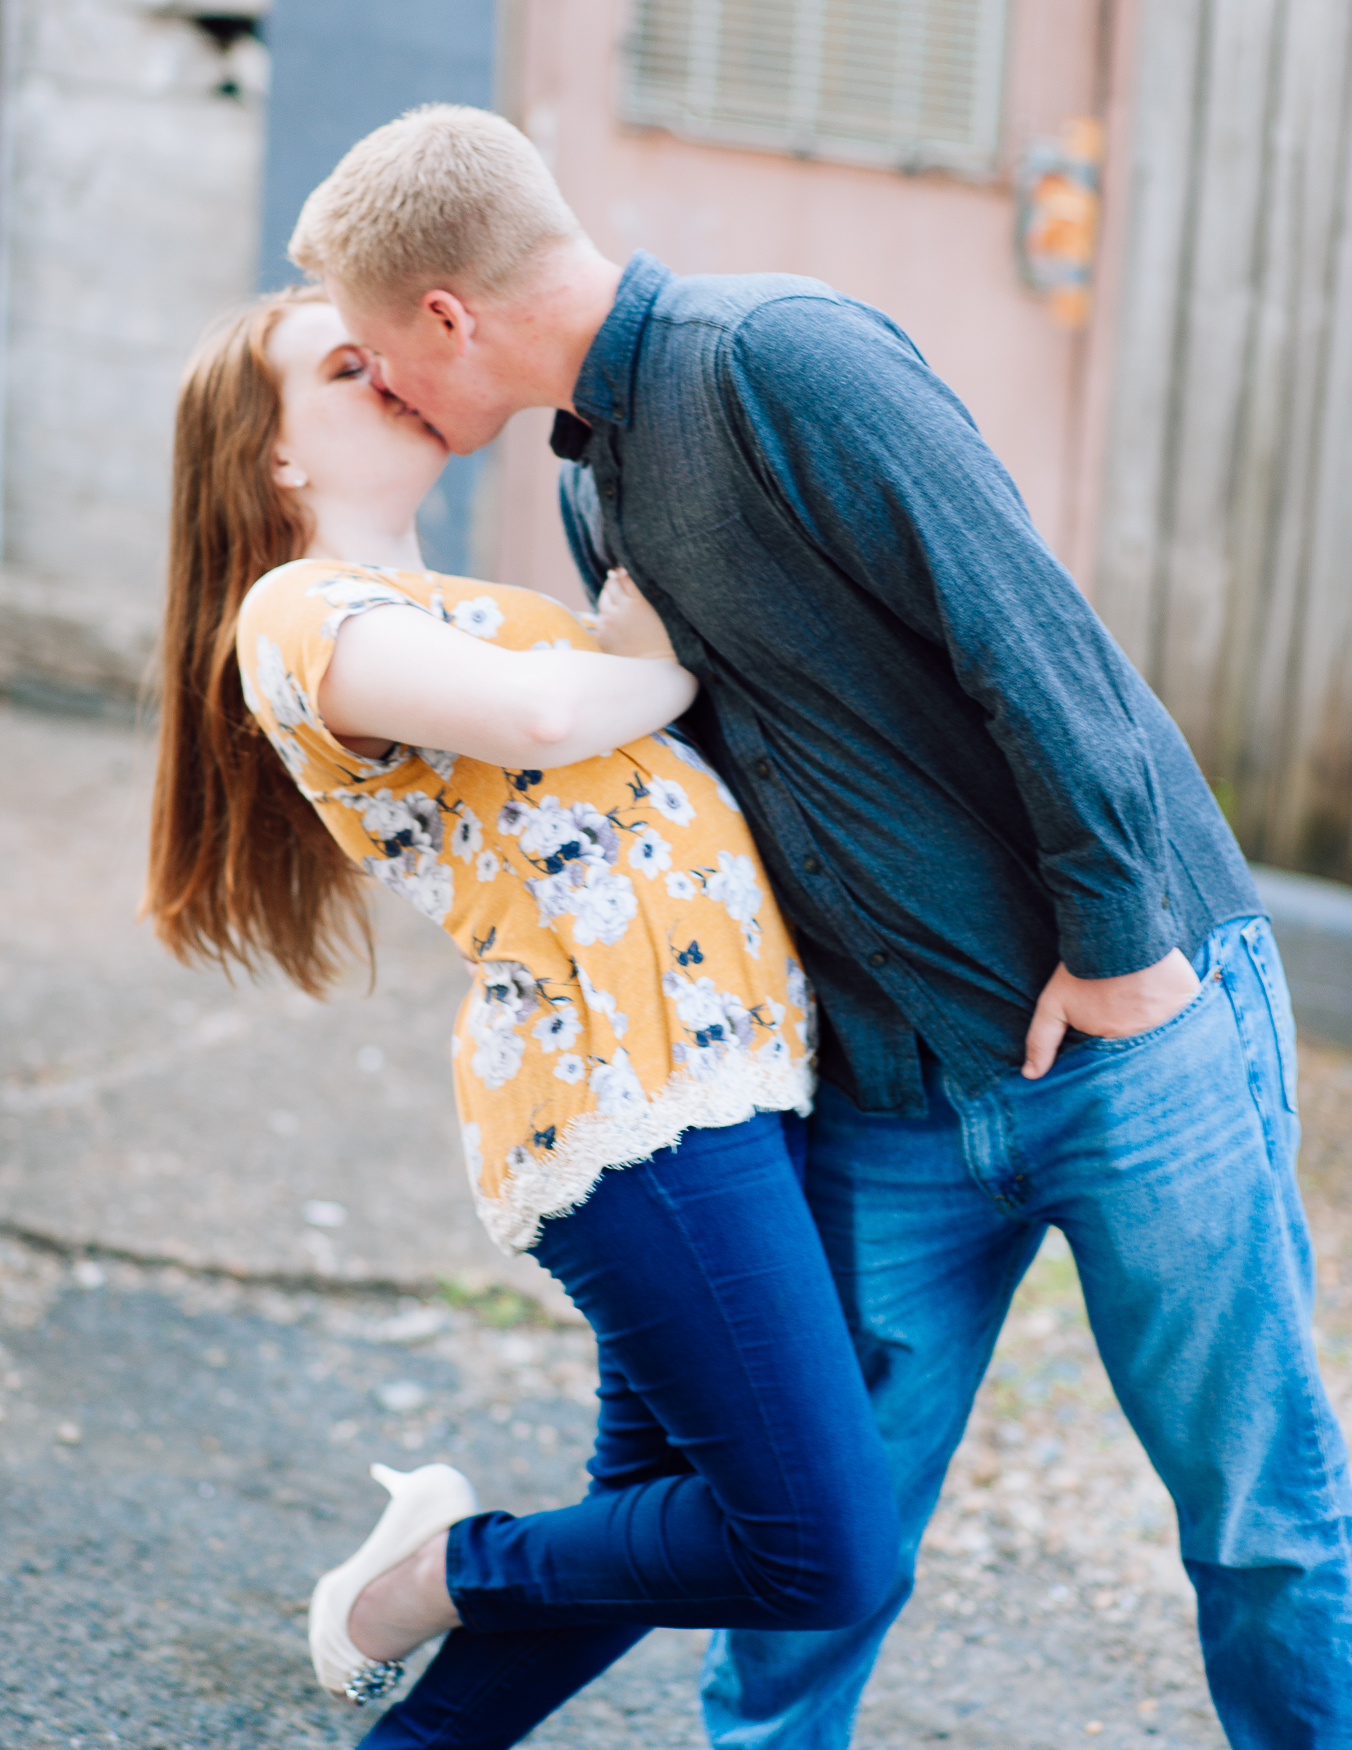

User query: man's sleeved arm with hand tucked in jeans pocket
[726,299,1195,1075]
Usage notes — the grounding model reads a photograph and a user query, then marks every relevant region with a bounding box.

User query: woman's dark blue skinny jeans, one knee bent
[364,1113,899,1750]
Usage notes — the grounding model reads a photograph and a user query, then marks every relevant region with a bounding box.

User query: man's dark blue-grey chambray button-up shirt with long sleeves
[553,252,1263,1113]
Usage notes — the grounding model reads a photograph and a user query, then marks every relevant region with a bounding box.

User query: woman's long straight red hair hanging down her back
[143,287,371,996]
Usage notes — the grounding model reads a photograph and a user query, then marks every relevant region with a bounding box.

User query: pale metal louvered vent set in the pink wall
[623,0,1007,177]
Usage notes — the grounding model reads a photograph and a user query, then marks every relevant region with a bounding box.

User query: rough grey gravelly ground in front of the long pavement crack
[0,1043,1352,1750]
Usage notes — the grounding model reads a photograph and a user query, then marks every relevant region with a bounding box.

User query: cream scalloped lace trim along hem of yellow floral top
[474,1055,817,1257]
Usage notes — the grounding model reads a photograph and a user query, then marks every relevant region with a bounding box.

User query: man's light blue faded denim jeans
[703,919,1352,1750]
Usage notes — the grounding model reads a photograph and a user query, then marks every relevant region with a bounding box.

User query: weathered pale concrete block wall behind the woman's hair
[0,0,268,702]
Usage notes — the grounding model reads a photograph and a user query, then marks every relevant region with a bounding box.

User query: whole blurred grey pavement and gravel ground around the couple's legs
[0,707,1352,1750]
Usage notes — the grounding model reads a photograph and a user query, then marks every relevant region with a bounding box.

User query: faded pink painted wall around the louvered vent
[495,0,1119,600]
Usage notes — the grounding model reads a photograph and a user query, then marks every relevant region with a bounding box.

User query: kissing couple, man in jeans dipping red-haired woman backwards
[149,105,1352,1750]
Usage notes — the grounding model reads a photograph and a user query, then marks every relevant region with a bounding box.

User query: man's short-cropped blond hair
[289,103,582,312]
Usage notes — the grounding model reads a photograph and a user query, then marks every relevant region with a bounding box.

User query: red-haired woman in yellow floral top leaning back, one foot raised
[149,291,896,1750]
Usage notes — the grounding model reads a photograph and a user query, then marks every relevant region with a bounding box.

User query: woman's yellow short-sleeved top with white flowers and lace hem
[238,560,813,1251]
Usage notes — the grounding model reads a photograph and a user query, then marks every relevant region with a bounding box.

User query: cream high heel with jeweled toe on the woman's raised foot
[310,1465,479,1708]
